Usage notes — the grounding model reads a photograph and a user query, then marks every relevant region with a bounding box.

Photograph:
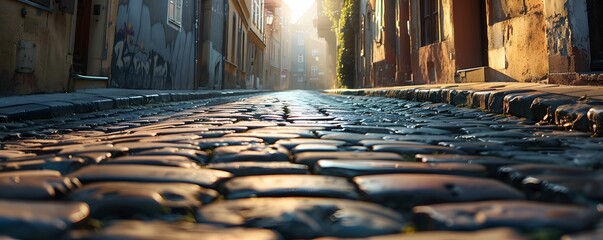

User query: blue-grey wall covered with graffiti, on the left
[111,0,196,89]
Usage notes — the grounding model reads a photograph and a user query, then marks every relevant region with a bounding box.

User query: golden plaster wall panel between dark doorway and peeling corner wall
[488,0,549,82]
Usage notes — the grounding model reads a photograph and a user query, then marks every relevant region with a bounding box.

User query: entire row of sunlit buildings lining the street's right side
[336,0,603,87]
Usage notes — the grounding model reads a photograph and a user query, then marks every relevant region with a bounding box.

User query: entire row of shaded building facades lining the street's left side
[0,0,280,95]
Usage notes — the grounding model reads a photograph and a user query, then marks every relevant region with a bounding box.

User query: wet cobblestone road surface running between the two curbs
[0,91,603,240]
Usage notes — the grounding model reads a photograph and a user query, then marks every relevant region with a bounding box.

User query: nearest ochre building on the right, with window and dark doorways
[409,0,603,84]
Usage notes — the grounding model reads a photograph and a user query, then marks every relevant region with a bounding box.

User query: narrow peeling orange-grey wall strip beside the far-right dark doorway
[544,0,590,79]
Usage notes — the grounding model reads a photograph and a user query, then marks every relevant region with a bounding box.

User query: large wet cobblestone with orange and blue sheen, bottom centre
[196,198,405,239]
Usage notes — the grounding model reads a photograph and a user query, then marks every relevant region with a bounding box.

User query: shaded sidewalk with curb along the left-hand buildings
[0,88,262,122]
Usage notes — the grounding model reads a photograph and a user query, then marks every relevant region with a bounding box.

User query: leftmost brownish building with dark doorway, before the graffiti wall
[0,0,117,96]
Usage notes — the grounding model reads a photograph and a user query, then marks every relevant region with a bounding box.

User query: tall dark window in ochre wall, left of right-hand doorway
[421,0,440,46]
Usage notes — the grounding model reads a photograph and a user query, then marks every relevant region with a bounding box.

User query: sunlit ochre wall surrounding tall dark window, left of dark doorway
[411,0,456,84]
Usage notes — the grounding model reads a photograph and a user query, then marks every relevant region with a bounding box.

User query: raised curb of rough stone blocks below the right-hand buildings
[324,83,603,135]
